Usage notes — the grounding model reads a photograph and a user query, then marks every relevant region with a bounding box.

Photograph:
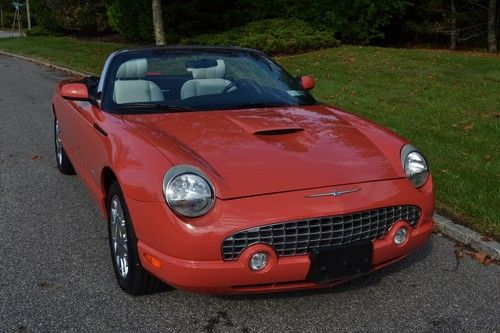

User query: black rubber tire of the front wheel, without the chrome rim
[107,181,166,295]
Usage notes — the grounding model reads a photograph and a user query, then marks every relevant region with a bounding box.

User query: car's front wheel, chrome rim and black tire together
[108,182,165,295]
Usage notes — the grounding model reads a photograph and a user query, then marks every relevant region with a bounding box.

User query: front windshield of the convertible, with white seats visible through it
[103,48,316,113]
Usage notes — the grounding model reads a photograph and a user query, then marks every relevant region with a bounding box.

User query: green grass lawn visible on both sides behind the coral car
[0,37,500,240]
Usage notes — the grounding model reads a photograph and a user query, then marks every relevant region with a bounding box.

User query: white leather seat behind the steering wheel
[181,59,231,99]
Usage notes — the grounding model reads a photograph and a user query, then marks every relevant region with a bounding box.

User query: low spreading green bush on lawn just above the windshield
[181,19,339,55]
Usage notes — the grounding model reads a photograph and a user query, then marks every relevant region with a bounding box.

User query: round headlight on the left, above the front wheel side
[163,165,215,217]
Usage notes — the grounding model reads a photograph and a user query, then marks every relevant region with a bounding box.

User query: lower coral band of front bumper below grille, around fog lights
[139,219,434,294]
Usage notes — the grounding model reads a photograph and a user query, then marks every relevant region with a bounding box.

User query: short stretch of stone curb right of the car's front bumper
[433,214,500,260]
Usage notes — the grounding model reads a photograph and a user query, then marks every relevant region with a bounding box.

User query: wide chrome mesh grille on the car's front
[222,206,420,260]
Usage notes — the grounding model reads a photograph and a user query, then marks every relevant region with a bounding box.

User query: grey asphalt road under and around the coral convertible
[0,56,500,332]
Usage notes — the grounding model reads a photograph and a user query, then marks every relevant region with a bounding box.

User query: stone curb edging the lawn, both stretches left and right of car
[0,50,500,260]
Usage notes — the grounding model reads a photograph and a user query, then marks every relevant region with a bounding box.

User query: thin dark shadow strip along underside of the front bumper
[215,237,434,301]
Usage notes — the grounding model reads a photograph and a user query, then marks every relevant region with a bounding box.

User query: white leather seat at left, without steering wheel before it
[113,58,164,104]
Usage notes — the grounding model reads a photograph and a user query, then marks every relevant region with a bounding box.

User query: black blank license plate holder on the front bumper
[307,242,373,283]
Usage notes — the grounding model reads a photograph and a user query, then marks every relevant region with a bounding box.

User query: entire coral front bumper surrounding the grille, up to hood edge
[126,180,434,294]
